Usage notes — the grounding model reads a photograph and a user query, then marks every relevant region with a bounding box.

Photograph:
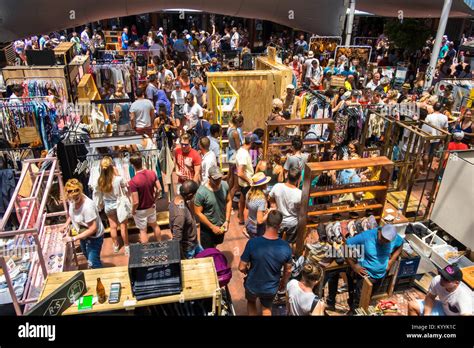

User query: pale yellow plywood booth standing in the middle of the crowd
[206,51,292,131]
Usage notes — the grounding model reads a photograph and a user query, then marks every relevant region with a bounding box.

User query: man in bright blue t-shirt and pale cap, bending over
[346,224,403,310]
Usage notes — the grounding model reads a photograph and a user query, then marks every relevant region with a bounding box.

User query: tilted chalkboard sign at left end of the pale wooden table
[25,272,87,317]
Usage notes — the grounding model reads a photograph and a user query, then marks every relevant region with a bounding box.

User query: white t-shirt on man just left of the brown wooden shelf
[270,183,302,226]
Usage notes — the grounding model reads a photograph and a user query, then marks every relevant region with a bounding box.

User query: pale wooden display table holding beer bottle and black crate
[40,257,220,315]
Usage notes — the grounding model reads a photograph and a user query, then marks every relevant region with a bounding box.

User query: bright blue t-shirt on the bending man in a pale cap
[346,228,403,279]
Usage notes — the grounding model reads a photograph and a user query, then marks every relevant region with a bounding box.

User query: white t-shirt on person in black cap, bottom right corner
[429,275,473,315]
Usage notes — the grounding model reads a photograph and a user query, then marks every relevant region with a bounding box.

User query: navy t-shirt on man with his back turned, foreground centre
[240,237,291,296]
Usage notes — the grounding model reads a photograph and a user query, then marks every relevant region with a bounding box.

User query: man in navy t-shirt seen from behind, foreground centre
[239,210,291,316]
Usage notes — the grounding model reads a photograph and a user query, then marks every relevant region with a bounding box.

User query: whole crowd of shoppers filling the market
[9,20,474,315]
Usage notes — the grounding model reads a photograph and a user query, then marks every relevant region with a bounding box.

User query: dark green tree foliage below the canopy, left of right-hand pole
[384,18,431,52]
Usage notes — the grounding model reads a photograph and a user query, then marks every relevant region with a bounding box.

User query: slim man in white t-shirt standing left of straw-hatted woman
[235,134,259,225]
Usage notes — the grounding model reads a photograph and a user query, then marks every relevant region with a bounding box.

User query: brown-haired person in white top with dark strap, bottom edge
[286,263,326,316]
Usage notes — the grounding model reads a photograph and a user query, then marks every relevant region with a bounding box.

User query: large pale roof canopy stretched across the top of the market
[0,0,474,42]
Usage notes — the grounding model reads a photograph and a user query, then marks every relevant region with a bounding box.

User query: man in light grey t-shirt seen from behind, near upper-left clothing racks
[130,88,155,137]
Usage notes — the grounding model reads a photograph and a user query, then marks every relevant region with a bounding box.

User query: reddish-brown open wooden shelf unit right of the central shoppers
[296,157,393,255]
